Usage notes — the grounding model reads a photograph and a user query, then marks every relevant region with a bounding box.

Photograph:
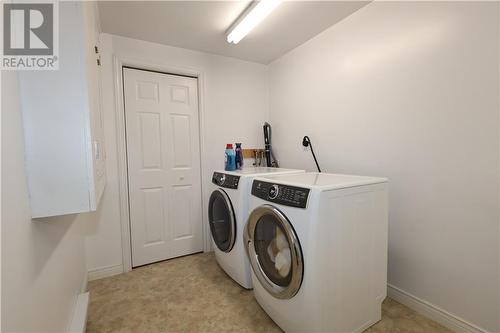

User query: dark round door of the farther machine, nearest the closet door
[208,189,236,252]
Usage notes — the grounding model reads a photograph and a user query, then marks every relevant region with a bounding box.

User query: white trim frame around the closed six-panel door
[113,54,211,272]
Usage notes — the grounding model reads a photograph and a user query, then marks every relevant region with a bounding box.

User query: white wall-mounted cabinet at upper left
[19,2,106,218]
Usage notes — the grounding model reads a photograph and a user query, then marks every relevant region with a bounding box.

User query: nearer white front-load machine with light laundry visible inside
[244,173,388,332]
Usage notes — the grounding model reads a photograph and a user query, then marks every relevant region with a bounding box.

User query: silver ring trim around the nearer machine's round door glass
[243,205,304,299]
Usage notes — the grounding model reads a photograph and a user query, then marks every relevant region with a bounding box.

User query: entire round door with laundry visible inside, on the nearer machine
[244,205,304,299]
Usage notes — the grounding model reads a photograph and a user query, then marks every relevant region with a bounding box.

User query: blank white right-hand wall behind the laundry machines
[269,2,500,332]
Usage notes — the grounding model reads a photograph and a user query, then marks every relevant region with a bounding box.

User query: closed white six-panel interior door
[123,68,203,266]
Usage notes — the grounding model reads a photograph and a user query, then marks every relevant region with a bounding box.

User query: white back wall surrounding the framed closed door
[86,34,268,271]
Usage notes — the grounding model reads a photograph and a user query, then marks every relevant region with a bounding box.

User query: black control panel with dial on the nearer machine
[252,180,310,208]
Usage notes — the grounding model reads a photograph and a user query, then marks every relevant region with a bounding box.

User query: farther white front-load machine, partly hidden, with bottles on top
[208,167,304,289]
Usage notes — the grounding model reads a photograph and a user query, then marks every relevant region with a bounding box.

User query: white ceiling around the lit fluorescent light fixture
[98,1,368,64]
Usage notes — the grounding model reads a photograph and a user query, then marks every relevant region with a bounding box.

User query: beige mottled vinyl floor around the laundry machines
[87,252,450,333]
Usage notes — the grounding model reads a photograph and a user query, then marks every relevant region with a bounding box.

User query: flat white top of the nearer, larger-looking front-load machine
[258,172,387,190]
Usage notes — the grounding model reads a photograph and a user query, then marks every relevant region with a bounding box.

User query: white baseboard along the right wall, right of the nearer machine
[387,284,488,333]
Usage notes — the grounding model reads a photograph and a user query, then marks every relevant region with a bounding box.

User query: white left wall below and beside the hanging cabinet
[1,71,93,332]
